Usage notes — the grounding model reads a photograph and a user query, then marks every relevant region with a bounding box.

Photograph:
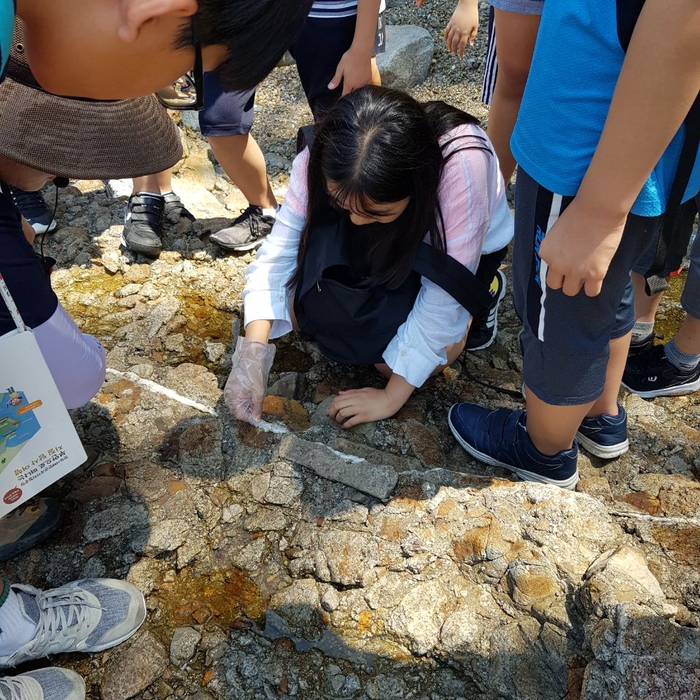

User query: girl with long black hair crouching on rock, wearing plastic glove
[224,86,513,428]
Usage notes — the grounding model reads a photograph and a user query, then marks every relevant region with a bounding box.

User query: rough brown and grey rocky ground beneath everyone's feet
[3,0,700,700]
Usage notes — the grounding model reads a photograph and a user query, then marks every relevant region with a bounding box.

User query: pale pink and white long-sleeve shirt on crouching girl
[243,124,513,387]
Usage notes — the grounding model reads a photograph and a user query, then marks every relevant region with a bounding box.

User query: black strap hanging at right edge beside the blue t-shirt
[644,95,700,296]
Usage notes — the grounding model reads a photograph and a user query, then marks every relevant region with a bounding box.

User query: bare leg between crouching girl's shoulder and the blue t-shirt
[487,10,540,184]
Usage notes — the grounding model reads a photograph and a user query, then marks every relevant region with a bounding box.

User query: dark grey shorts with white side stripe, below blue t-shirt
[513,168,662,406]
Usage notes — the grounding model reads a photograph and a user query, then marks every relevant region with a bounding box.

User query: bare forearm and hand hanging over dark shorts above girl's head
[328,0,381,95]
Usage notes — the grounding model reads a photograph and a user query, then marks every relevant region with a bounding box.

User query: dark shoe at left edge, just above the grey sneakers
[0,498,61,562]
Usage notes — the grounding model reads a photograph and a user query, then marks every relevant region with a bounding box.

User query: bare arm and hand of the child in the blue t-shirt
[540,0,700,296]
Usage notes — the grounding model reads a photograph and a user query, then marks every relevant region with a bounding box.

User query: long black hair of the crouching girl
[290,86,478,288]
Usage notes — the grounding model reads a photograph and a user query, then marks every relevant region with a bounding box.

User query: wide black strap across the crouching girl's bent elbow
[413,242,493,316]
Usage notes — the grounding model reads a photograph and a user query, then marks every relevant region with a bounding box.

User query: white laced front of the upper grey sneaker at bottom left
[13,585,102,658]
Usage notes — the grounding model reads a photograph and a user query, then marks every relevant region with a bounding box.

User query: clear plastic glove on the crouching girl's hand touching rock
[224,338,276,425]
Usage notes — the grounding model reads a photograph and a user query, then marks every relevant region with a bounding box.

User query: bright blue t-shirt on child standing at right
[511,0,700,216]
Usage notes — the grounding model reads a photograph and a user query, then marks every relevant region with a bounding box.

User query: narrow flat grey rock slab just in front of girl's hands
[278,435,398,501]
